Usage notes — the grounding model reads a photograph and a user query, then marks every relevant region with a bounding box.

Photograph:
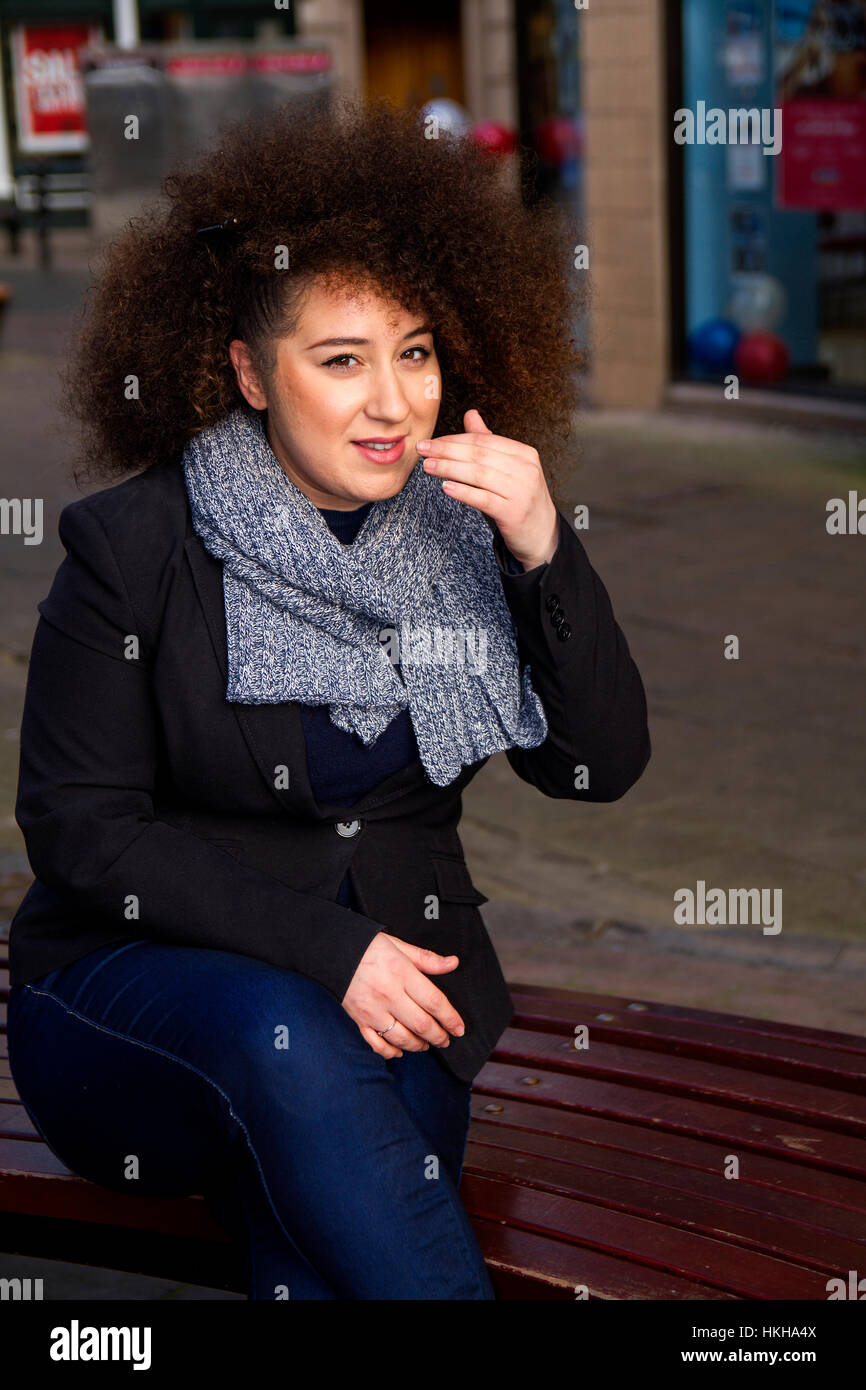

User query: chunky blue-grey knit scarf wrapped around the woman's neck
[183,406,548,787]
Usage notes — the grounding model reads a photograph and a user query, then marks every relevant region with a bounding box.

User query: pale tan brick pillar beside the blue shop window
[580,0,673,410]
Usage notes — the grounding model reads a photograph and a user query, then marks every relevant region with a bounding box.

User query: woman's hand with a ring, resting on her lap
[342,931,464,1058]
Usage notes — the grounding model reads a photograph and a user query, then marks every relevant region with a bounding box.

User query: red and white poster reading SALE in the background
[13,24,100,153]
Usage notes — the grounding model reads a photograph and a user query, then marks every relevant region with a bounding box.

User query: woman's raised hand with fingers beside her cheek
[416,410,559,570]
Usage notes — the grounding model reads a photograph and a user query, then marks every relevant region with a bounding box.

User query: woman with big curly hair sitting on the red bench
[10,101,649,1300]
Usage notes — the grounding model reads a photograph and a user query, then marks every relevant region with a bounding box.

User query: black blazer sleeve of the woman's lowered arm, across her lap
[15,499,385,999]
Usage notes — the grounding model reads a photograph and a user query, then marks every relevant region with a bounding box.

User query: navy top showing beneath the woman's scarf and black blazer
[300,502,523,912]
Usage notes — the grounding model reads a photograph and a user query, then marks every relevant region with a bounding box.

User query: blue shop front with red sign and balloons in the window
[681,0,866,399]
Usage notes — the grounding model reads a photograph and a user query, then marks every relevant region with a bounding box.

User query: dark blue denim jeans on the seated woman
[8,941,495,1300]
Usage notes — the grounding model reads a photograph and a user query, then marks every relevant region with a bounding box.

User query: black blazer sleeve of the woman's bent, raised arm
[493,509,651,801]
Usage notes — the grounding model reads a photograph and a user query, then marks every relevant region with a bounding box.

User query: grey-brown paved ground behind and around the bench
[0,236,866,1298]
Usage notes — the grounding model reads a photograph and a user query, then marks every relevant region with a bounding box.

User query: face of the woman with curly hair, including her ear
[229,282,442,512]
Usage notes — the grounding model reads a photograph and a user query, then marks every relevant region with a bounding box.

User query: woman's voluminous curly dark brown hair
[60,97,587,508]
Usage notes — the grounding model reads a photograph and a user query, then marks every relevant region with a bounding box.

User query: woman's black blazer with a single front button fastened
[10,460,651,1081]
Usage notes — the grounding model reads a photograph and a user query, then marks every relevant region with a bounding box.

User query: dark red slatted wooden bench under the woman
[0,948,866,1301]
